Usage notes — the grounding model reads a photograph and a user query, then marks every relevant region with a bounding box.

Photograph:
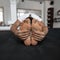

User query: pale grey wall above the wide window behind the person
[17,0,44,20]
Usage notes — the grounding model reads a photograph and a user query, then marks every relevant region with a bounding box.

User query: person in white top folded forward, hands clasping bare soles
[11,13,48,46]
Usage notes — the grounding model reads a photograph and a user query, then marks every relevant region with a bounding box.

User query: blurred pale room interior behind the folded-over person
[0,0,60,29]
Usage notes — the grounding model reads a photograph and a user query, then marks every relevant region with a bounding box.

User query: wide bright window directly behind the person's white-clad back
[17,9,42,18]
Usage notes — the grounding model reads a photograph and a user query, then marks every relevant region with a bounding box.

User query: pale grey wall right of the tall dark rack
[54,0,60,28]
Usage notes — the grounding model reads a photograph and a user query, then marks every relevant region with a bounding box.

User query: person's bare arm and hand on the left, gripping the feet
[10,20,29,40]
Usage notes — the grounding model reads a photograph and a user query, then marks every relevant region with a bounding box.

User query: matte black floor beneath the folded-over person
[0,28,60,60]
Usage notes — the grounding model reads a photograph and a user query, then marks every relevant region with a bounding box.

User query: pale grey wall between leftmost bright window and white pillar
[0,0,10,24]
